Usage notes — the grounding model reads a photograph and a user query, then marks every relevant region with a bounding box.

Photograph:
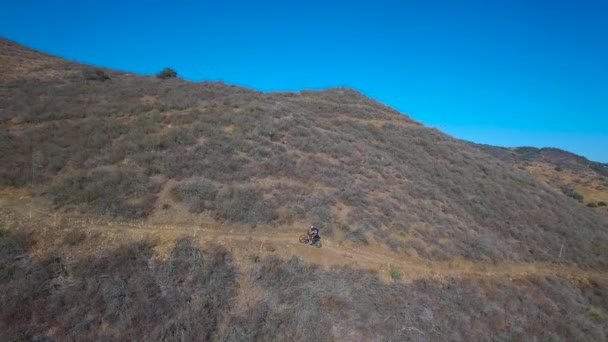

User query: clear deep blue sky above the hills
[0,0,608,162]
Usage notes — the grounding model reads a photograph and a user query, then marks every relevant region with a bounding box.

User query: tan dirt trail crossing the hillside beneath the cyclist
[0,191,608,282]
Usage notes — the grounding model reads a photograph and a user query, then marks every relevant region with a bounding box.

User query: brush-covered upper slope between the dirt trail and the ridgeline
[0,37,608,268]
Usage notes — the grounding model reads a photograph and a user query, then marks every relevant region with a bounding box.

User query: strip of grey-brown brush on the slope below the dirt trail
[0,232,608,341]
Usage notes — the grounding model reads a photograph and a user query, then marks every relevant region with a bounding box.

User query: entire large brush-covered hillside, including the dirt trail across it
[0,40,608,341]
